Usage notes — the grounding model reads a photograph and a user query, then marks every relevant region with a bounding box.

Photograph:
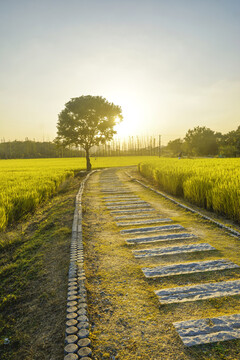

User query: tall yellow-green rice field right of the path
[138,158,240,223]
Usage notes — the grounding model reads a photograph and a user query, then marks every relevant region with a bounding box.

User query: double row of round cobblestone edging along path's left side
[64,170,96,360]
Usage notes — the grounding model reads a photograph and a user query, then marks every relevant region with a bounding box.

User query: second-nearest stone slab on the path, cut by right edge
[155,280,240,304]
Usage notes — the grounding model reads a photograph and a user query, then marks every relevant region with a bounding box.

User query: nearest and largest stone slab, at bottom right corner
[173,314,240,346]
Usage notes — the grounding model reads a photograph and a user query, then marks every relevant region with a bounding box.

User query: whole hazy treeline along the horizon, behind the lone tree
[0,126,240,159]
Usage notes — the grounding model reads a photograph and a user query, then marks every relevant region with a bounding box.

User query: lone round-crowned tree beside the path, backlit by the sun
[56,95,122,171]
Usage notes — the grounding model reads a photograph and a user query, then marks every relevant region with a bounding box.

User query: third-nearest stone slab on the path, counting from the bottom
[142,259,239,278]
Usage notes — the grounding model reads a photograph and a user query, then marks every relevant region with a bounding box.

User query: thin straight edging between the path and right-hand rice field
[125,172,240,237]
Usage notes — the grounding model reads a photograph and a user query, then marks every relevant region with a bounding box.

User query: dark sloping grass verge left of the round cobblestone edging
[0,178,79,360]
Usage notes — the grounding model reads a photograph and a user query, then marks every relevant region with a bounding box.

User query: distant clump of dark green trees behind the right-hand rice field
[164,126,240,157]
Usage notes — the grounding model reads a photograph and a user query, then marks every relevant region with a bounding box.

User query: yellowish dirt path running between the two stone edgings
[83,169,240,360]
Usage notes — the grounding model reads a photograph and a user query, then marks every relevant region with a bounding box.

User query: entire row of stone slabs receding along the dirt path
[99,169,240,346]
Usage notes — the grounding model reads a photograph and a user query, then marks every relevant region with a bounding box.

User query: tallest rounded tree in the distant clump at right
[184,126,221,156]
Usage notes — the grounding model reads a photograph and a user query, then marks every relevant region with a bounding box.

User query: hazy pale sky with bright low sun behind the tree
[0,0,240,145]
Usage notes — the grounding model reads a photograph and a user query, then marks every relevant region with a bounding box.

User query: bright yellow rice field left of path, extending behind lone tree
[0,156,154,230]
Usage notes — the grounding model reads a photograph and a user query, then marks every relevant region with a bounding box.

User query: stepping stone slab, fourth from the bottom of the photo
[133,243,216,258]
